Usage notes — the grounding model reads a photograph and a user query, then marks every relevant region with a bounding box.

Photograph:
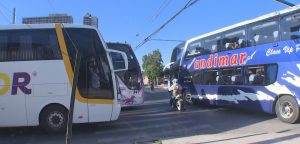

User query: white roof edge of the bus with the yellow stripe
[0,23,97,30]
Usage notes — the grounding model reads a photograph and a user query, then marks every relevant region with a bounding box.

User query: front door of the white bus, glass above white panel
[82,56,114,122]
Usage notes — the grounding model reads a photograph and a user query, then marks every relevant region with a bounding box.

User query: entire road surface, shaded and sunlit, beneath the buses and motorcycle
[0,89,300,144]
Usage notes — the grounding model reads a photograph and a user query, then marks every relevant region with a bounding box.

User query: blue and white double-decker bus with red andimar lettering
[179,6,300,123]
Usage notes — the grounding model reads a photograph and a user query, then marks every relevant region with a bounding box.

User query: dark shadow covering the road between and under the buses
[0,87,298,144]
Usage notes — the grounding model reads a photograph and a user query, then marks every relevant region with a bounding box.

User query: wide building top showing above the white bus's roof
[22,14,73,24]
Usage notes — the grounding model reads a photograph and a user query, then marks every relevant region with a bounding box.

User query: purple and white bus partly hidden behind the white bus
[107,42,144,106]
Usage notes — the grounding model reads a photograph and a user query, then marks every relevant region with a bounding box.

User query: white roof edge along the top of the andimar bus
[185,5,300,47]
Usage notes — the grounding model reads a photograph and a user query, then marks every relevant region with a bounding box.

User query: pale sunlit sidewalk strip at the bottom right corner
[162,132,300,144]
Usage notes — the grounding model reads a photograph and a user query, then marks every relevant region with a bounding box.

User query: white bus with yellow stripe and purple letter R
[0,24,128,132]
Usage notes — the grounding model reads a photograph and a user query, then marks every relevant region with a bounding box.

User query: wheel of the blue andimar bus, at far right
[275,95,299,124]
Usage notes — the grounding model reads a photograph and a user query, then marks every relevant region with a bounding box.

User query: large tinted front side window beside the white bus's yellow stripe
[64,28,114,99]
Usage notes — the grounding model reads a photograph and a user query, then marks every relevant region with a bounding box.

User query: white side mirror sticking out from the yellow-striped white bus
[107,49,128,72]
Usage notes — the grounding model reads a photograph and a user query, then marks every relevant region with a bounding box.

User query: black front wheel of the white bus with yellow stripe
[40,105,68,133]
